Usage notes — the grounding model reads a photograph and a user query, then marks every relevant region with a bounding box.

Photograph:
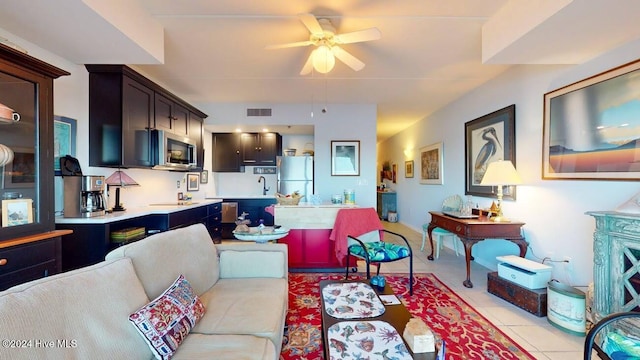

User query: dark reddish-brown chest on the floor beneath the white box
[487,271,547,317]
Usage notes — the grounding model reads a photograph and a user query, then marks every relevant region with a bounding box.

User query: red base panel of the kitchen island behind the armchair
[278,229,345,269]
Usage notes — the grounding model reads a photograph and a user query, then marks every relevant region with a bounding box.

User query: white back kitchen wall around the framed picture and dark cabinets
[196,103,377,207]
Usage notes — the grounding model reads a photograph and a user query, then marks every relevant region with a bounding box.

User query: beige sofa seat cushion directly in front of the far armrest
[192,278,289,352]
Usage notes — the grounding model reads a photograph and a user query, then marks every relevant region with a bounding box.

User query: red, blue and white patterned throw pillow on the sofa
[129,275,205,359]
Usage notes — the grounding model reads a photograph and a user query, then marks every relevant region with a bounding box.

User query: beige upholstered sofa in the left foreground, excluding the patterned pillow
[0,224,288,359]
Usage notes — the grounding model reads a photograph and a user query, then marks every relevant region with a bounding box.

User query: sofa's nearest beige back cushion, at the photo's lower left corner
[0,259,152,359]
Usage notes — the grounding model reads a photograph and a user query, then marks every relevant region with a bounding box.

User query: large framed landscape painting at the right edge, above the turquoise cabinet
[542,60,640,180]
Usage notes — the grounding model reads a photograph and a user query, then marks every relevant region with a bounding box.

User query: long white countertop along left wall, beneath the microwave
[55,198,222,224]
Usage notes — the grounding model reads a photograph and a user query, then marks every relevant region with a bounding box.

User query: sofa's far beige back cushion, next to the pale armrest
[106,224,220,299]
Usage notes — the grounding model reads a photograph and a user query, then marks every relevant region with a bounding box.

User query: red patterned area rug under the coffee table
[280,273,535,360]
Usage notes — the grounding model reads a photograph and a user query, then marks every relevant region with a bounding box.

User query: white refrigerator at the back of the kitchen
[276,156,313,202]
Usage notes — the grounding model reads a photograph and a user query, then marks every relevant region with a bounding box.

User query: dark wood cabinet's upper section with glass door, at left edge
[0,45,69,241]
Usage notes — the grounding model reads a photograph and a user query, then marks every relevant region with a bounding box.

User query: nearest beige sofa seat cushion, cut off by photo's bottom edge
[172,333,280,360]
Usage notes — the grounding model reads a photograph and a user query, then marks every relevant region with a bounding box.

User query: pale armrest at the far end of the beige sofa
[216,243,289,279]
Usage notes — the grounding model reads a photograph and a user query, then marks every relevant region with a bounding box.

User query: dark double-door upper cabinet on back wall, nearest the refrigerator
[241,133,282,166]
